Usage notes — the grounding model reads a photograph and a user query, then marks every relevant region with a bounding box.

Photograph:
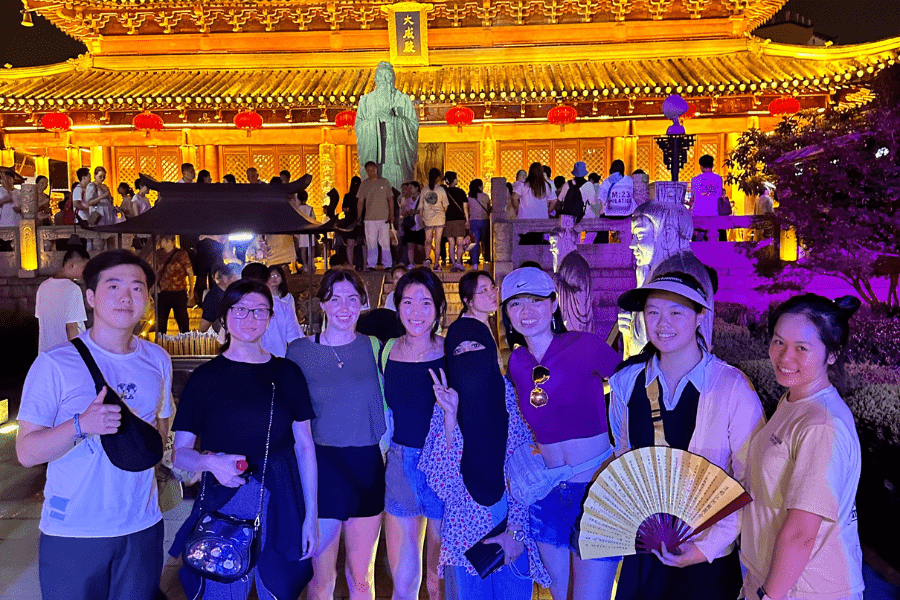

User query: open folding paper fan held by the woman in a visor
[578,446,751,559]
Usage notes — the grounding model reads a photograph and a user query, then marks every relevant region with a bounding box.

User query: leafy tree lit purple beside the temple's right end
[726,65,900,305]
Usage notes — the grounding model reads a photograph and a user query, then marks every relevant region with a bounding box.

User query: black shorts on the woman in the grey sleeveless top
[316,444,384,521]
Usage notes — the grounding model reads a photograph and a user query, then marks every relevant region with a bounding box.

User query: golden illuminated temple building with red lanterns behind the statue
[0,0,900,214]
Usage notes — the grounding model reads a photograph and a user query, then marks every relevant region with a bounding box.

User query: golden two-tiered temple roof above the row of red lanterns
[0,0,900,128]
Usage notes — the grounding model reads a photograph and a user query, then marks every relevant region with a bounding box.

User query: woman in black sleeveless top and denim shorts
[381,268,447,600]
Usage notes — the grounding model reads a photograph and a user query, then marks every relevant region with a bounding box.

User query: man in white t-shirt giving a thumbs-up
[16,250,172,600]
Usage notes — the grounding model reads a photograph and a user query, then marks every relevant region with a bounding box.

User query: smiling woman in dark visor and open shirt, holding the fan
[609,272,764,600]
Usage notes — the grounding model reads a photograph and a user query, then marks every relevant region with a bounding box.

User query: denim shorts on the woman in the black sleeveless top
[384,442,444,519]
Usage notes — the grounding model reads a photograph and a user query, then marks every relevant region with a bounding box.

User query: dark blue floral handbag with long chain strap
[182,383,275,583]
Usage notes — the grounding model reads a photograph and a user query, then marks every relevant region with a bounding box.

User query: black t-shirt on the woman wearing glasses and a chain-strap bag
[172,355,316,462]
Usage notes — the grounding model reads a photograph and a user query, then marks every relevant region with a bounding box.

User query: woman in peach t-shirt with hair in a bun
[741,294,864,600]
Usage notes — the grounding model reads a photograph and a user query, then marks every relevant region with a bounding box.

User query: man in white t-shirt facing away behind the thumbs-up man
[34,248,91,352]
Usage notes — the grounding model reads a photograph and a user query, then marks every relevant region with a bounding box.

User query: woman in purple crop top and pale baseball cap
[501,267,619,600]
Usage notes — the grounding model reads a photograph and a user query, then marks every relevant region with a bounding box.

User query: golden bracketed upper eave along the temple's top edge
[25,0,787,43]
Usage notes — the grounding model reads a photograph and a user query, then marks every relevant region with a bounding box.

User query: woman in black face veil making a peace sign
[419,319,550,600]
